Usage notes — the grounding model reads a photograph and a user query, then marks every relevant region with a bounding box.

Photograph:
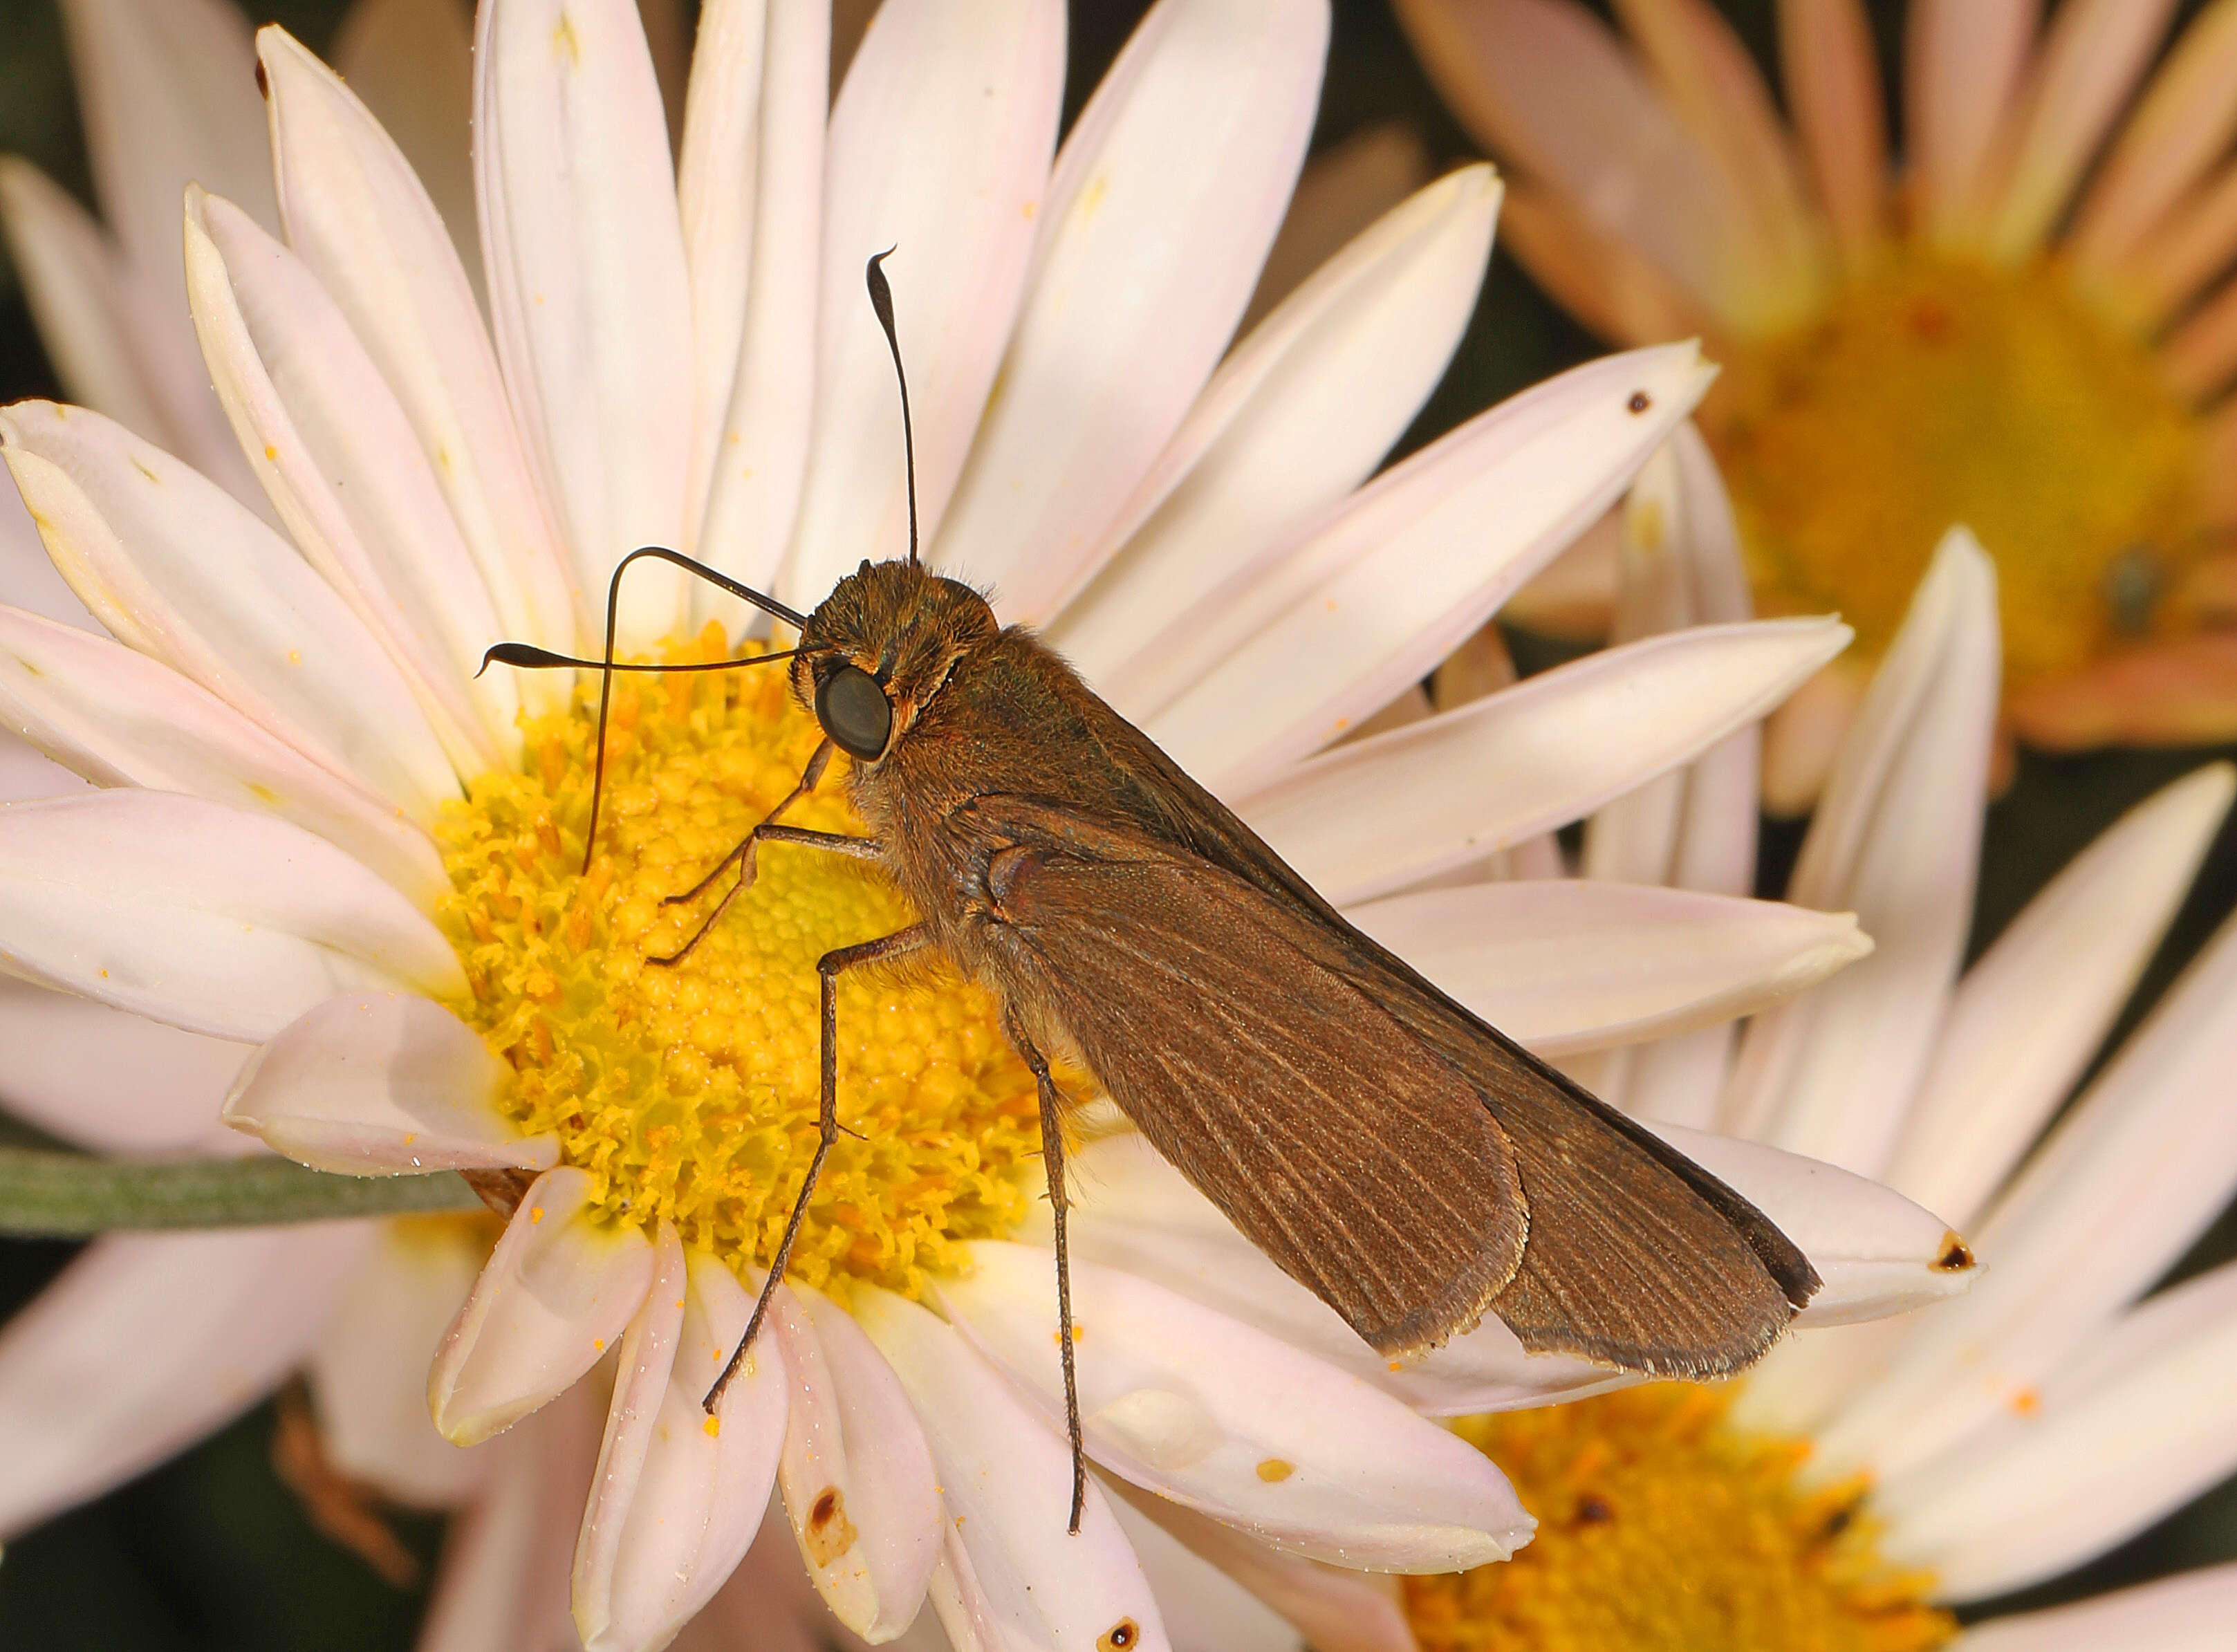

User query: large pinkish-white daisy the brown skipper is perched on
[0,0,1977,1645]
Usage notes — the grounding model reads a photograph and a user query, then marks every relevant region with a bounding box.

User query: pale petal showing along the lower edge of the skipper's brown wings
[1018,1133,1635,1417]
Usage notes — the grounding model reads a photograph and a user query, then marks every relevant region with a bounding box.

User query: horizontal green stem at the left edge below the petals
[0,1149,483,1238]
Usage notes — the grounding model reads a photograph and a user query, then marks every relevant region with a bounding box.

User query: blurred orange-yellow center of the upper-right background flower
[1711,253,2201,685]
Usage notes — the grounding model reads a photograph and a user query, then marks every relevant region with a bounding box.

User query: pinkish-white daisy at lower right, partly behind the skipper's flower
[1313,420,2237,1652]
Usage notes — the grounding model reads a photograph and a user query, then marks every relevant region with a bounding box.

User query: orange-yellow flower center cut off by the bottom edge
[1405,1384,1958,1652]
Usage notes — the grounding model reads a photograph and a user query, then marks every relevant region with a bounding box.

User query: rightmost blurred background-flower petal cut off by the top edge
[1984,0,2174,257]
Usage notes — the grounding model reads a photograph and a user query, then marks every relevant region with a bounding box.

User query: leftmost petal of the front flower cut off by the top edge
[474,0,691,647]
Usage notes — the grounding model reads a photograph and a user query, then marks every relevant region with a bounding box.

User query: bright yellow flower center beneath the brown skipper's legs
[438,627,1040,1294]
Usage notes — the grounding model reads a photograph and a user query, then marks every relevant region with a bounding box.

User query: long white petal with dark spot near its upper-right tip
[1127,345,1714,790]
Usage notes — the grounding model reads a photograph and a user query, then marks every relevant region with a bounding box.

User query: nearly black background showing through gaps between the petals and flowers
[0,0,2237,1652]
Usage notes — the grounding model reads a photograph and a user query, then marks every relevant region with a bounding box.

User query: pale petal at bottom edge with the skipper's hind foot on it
[855,1285,1170,1652]
